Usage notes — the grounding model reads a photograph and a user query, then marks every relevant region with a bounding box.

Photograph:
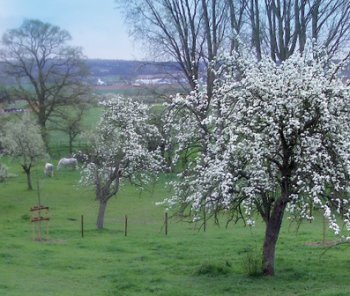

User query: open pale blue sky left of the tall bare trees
[0,0,144,60]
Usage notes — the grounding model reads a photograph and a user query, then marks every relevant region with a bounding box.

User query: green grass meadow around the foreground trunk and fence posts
[0,162,350,296]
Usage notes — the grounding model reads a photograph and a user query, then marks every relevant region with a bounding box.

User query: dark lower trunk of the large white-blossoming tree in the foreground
[262,199,287,276]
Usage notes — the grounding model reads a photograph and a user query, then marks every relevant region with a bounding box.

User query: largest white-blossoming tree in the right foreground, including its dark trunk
[164,51,350,275]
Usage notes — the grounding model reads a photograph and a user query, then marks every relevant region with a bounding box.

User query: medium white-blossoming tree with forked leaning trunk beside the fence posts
[81,97,160,229]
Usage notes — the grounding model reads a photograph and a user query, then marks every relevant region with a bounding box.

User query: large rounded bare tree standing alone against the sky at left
[1,20,87,144]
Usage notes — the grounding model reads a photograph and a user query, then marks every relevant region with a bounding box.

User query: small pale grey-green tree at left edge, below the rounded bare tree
[2,113,46,190]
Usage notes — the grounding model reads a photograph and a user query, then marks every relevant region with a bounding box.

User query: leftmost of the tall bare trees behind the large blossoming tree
[116,0,203,89]
